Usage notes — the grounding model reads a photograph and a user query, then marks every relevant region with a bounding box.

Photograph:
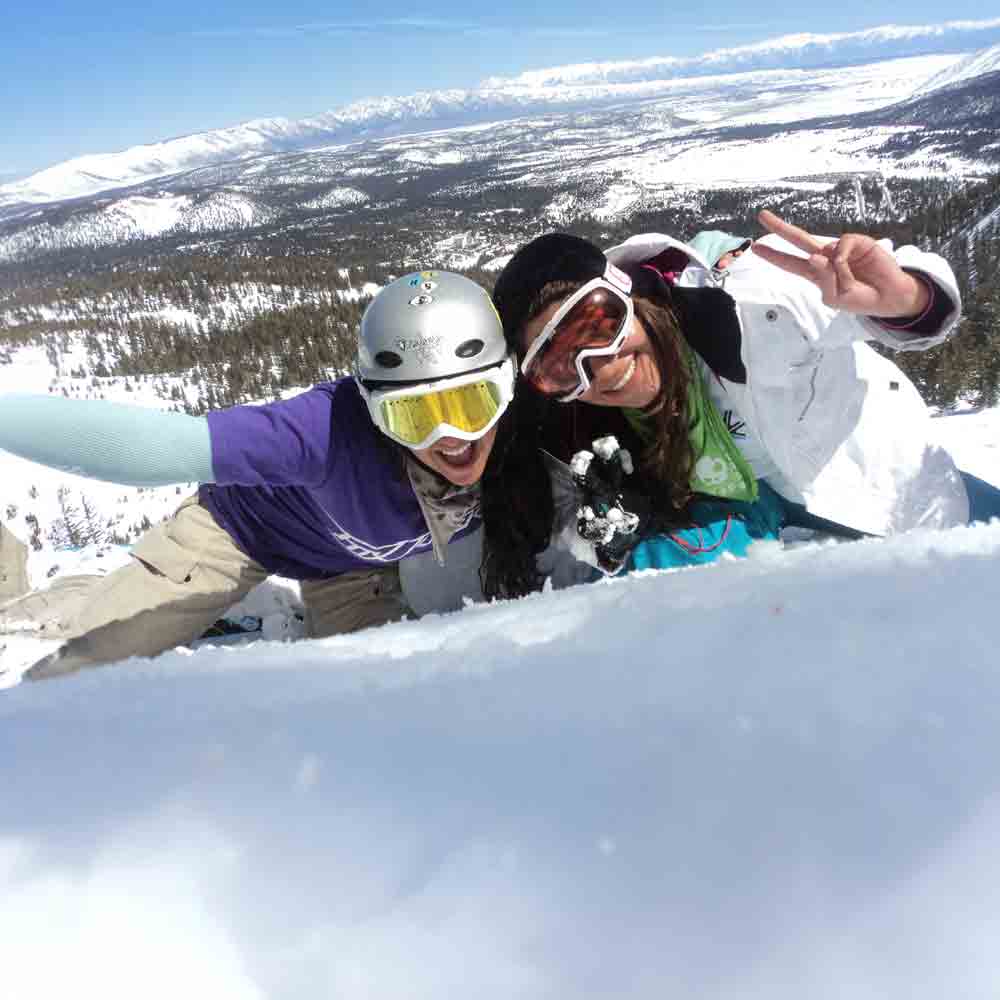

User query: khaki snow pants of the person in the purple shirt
[0,496,407,665]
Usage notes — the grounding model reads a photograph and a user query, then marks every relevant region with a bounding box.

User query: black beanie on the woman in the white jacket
[493,233,608,350]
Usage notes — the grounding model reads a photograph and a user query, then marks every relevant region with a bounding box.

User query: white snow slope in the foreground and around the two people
[0,326,1000,1000]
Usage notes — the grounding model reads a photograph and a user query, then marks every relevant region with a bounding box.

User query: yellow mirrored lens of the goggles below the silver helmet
[379,380,504,446]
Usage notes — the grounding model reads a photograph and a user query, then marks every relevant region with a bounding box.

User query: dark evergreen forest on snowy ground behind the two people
[0,174,1000,413]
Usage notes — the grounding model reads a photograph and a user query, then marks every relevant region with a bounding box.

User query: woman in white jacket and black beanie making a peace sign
[484,206,1000,593]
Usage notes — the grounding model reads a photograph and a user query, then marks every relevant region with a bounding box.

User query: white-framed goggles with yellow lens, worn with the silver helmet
[362,360,514,448]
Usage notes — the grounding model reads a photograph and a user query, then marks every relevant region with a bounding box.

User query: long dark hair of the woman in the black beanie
[480,275,694,597]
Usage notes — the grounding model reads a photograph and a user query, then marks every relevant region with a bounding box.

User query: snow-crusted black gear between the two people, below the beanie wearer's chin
[570,437,652,574]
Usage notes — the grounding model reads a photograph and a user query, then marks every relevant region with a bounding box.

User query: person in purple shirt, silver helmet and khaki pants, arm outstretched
[0,271,515,678]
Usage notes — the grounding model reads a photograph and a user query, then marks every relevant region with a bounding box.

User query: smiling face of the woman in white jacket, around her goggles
[520,301,660,409]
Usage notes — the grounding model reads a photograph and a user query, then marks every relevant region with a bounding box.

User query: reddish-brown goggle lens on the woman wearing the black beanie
[525,288,628,396]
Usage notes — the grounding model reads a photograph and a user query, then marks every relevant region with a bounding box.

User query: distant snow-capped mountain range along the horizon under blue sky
[0,19,1000,209]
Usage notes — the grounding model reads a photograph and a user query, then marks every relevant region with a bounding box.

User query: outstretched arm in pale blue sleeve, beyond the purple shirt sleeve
[0,395,214,486]
